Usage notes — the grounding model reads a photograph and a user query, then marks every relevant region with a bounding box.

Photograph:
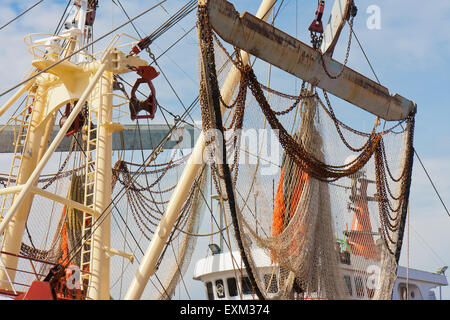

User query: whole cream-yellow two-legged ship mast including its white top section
[0,0,148,300]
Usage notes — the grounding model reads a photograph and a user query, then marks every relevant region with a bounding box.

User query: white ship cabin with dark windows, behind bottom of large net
[194,249,448,300]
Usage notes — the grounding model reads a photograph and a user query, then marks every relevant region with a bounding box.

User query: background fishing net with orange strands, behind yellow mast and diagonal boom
[0,77,206,299]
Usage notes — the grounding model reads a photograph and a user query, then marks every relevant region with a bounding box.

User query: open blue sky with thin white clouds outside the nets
[0,0,450,299]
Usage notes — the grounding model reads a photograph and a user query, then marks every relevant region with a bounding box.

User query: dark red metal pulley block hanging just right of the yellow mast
[129,66,159,120]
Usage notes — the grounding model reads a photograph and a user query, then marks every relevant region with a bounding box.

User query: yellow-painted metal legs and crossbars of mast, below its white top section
[0,25,148,299]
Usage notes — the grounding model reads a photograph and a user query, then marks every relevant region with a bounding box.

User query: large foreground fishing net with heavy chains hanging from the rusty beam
[198,6,414,299]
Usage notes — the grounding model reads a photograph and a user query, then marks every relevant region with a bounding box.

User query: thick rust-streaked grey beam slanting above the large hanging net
[208,0,416,121]
